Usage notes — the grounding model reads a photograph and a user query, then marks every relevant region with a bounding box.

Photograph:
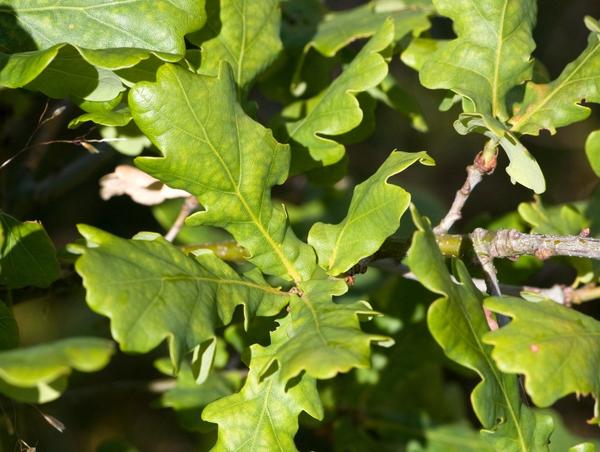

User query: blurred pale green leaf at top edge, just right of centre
[305,0,432,57]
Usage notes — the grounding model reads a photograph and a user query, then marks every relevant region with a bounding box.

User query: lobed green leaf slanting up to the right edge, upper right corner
[510,17,600,135]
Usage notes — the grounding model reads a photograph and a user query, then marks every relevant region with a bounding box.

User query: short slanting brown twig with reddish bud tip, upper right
[433,147,497,234]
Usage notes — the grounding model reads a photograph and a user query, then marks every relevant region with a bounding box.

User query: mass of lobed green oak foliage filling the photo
[0,0,600,452]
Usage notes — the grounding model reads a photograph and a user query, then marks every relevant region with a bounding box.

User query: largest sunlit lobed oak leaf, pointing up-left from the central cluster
[130,64,316,281]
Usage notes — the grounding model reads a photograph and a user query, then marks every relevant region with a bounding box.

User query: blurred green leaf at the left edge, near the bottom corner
[0,338,114,403]
